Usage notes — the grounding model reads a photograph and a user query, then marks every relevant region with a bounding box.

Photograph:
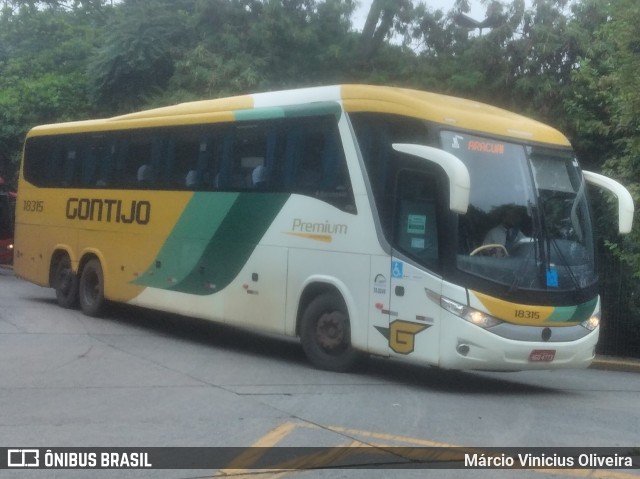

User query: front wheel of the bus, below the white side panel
[300,292,360,372]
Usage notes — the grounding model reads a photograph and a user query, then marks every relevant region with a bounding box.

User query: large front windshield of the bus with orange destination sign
[441,131,597,291]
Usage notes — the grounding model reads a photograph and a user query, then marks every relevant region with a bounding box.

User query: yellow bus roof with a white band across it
[29,85,570,146]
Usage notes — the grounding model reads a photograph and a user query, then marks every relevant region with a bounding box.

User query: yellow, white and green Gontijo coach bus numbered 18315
[15,85,634,371]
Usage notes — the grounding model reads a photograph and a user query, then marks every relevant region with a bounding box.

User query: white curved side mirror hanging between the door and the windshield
[393,143,471,214]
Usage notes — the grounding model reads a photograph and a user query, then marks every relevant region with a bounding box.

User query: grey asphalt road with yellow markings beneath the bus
[0,269,640,479]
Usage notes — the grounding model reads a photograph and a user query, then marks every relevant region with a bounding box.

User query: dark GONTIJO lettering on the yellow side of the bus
[66,198,151,225]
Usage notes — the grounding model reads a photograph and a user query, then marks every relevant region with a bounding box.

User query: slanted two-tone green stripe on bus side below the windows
[135,193,290,295]
